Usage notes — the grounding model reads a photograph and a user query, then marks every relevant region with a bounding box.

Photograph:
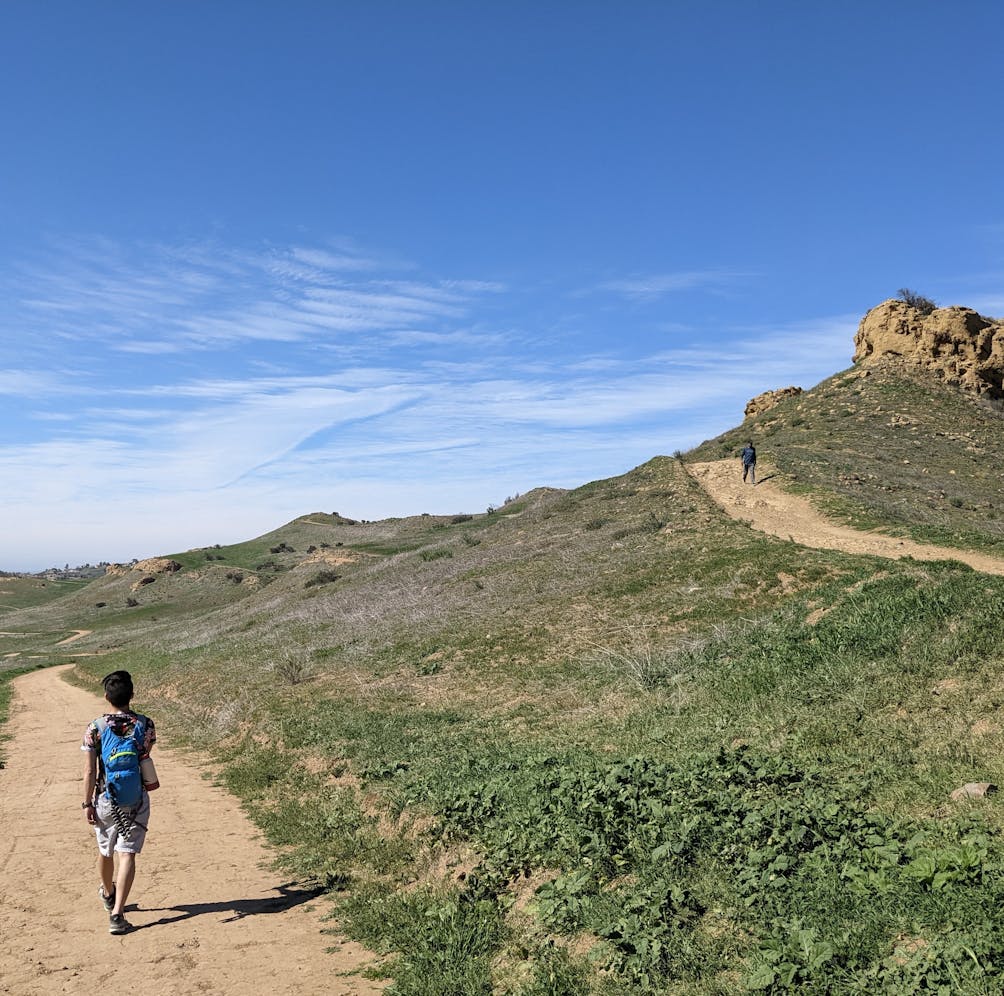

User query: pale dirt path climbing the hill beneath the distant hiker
[687,460,1004,574]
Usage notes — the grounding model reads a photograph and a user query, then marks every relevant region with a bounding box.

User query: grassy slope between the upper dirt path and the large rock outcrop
[687,365,1004,553]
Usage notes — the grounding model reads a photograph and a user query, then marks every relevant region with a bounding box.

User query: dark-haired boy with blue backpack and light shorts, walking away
[80,671,160,934]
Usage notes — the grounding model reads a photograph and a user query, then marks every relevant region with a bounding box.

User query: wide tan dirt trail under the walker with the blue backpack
[0,668,383,996]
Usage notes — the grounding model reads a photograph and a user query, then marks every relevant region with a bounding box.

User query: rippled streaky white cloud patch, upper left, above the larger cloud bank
[9,234,497,355]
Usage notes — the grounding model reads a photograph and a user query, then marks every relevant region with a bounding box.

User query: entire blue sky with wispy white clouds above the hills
[0,0,1004,570]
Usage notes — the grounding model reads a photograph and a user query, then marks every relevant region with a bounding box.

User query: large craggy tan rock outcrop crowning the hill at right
[854,300,1004,399]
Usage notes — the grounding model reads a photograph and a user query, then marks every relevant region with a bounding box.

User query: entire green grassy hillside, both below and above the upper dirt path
[0,361,1004,996]
